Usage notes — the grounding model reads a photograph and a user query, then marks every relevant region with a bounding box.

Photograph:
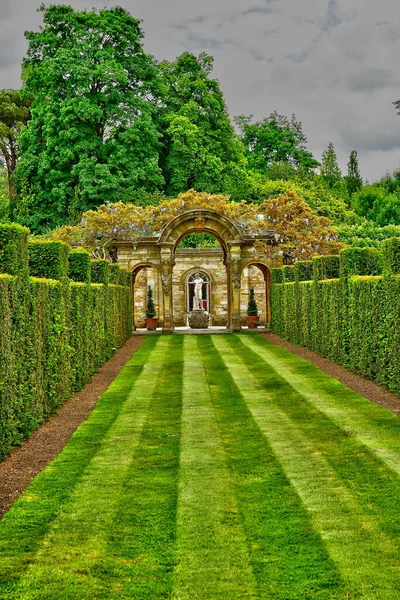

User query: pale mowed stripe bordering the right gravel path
[242,336,400,474]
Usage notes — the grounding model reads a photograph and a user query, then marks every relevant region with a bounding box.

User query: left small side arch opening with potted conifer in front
[132,264,164,330]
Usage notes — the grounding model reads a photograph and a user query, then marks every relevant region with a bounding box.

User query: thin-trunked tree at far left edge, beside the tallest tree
[0,90,32,209]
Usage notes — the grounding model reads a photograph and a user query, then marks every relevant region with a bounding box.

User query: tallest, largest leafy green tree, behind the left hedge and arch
[15,5,163,231]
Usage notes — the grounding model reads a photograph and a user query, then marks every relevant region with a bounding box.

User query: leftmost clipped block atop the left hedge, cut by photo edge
[0,223,29,275]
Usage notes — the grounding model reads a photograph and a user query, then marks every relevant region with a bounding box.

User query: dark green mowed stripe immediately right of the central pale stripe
[199,336,345,600]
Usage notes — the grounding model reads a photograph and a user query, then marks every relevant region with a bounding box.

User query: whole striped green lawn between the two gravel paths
[0,335,400,600]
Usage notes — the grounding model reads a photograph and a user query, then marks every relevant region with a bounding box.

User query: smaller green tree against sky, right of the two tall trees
[235,112,319,175]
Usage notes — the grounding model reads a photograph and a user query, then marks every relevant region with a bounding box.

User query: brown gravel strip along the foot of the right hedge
[262,333,400,415]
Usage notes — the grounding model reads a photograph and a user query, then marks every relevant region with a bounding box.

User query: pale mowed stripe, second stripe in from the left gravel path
[0,340,169,599]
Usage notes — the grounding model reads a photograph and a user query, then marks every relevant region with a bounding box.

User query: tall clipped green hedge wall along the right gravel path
[271,238,400,394]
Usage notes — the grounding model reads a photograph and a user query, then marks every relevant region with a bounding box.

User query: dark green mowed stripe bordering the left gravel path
[0,340,155,598]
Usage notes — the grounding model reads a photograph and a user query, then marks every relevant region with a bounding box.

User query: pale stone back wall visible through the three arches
[134,248,266,328]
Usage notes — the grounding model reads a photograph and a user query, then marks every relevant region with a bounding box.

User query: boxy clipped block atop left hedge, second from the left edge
[28,240,70,280]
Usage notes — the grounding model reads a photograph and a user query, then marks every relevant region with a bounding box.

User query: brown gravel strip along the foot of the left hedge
[0,336,144,518]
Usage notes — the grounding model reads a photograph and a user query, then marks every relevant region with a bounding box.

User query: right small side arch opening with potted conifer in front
[240,262,271,327]
